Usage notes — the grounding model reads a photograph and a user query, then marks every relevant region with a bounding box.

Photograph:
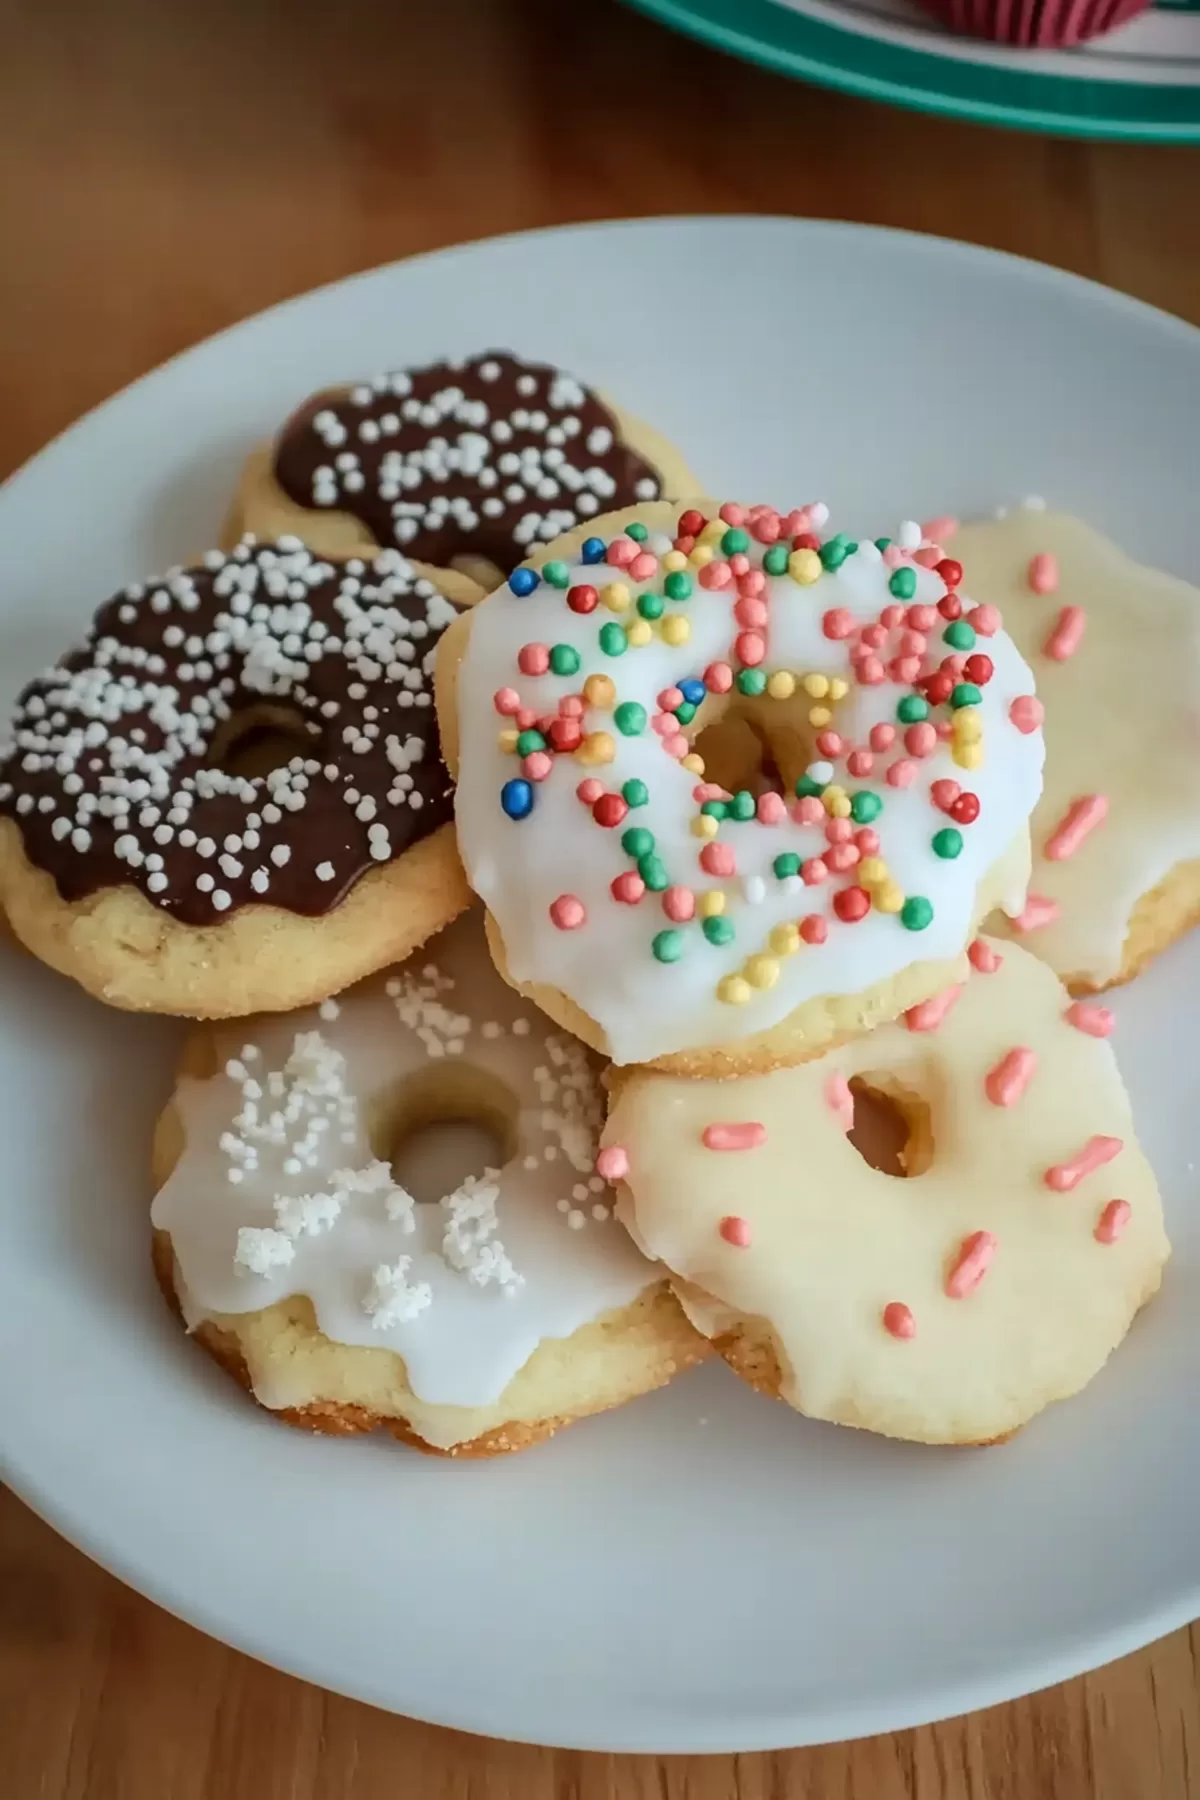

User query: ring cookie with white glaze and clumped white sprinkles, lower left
[153,913,707,1454]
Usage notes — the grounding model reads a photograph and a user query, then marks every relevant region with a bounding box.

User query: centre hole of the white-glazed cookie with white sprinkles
[369,1062,518,1206]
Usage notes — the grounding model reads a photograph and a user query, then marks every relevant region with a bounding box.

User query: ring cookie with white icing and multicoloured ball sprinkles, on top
[437,502,1042,1073]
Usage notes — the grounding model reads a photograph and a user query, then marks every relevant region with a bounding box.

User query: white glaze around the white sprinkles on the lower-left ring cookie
[151,913,658,1436]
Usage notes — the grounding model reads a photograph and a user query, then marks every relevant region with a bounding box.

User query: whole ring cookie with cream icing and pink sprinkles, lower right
[601,940,1169,1444]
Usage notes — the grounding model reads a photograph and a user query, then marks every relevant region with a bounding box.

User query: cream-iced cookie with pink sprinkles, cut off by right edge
[954,506,1200,994]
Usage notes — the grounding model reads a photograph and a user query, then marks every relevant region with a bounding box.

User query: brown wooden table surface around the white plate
[0,0,1200,1800]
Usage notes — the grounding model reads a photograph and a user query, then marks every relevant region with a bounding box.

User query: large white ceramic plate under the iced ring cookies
[0,220,1200,1750]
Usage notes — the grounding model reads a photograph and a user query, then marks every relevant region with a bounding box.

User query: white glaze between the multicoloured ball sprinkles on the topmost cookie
[455,508,1042,1064]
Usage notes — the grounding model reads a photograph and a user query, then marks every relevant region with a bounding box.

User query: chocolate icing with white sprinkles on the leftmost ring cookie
[0,538,453,925]
